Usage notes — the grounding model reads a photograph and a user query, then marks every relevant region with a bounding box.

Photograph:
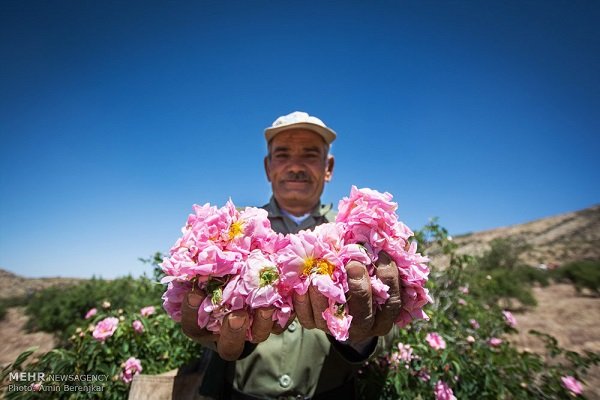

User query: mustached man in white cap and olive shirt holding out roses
[182,112,400,399]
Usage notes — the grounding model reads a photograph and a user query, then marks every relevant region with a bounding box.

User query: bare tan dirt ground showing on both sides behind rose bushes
[0,285,600,400]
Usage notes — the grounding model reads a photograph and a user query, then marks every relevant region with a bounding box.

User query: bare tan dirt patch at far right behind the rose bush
[510,284,600,400]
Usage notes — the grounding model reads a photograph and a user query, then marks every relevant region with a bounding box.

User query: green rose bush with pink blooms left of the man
[0,301,202,400]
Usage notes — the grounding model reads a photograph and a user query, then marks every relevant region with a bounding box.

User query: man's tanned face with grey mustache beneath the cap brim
[265,129,333,215]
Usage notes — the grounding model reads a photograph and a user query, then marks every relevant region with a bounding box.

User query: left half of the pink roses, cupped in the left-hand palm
[161,200,292,335]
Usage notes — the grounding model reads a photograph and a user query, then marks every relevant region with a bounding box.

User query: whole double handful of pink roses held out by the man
[161,186,431,340]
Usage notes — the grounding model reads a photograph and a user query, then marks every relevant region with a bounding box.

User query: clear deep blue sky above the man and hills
[0,0,600,278]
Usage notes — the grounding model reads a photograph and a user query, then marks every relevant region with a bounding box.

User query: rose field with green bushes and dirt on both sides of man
[0,217,600,399]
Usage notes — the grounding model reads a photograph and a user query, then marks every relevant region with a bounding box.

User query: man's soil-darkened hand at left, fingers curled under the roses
[181,291,294,361]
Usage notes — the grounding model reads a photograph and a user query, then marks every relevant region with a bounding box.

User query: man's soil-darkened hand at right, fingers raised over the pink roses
[294,252,401,345]
